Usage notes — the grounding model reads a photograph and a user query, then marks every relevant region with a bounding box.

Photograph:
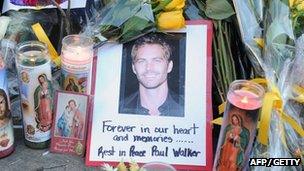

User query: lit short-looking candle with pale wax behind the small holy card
[61,35,93,94]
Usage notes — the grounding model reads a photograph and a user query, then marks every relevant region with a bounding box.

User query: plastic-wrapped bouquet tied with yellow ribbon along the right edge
[234,0,304,170]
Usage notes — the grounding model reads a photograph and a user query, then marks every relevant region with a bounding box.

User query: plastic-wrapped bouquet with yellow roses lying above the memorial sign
[84,0,185,43]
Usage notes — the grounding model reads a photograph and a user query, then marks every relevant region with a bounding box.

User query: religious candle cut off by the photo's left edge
[0,51,14,158]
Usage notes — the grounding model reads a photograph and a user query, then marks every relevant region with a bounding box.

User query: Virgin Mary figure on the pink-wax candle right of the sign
[217,113,250,171]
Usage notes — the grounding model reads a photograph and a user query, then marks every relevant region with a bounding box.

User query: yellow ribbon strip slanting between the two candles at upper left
[32,23,60,67]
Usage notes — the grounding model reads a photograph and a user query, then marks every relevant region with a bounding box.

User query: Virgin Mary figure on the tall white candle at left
[34,74,53,132]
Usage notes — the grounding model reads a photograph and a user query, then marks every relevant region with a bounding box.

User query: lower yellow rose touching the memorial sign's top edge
[157,10,185,30]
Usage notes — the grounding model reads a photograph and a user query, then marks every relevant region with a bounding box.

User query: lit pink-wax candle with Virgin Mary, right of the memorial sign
[213,80,264,171]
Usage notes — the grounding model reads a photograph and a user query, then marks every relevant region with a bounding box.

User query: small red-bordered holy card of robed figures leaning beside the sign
[50,91,89,156]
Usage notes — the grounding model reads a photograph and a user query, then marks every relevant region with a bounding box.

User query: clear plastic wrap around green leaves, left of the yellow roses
[83,0,155,43]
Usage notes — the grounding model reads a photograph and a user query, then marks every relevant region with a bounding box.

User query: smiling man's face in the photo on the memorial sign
[132,44,173,89]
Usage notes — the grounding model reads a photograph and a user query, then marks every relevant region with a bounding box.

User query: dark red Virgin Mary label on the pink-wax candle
[215,101,259,171]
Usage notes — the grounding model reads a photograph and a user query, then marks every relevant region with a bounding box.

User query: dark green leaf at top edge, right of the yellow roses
[205,0,235,20]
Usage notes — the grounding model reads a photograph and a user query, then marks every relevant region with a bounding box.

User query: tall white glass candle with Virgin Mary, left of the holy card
[16,41,54,149]
